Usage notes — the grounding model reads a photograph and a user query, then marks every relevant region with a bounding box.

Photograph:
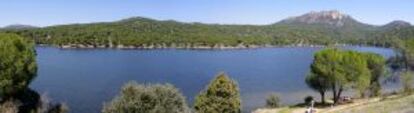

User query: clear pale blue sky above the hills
[0,0,414,26]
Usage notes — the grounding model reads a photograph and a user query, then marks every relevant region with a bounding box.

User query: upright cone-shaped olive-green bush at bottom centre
[194,73,241,113]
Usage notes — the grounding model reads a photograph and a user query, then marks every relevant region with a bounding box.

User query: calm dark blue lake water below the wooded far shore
[31,47,394,113]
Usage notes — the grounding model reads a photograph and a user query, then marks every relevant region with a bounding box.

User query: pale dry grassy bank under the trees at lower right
[253,95,414,113]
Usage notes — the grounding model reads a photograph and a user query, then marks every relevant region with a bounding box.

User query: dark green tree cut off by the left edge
[0,33,37,98]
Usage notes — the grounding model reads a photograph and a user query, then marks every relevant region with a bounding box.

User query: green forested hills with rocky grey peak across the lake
[0,11,414,48]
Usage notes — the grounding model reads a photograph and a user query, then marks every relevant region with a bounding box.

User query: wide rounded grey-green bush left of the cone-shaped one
[102,82,189,113]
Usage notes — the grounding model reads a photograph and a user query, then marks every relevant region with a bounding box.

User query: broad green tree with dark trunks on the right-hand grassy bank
[307,48,371,103]
